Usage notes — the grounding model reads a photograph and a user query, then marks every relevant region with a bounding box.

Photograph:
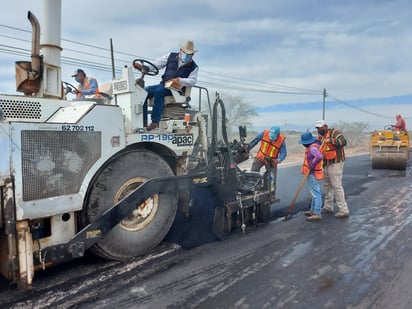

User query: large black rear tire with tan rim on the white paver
[83,150,178,260]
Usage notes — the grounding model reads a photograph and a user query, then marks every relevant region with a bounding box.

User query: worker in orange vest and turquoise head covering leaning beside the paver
[249,126,287,196]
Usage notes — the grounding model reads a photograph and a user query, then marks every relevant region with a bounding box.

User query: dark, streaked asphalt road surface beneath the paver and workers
[0,156,412,308]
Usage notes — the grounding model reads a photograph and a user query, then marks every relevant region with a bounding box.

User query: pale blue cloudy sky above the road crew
[0,0,412,129]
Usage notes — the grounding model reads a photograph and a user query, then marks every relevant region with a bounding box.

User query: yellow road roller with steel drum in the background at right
[370,125,409,170]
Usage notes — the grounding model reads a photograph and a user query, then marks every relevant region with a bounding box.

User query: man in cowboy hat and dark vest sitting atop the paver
[133,40,199,131]
